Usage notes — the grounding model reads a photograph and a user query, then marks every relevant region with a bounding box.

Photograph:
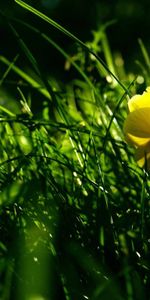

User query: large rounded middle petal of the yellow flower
[124,107,150,146]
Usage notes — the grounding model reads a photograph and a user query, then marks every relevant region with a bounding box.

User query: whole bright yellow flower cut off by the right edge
[124,87,150,169]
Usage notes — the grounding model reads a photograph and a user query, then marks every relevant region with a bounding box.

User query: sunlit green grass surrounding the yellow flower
[0,0,150,300]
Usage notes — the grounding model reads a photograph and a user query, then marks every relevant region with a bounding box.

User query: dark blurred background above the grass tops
[0,0,150,76]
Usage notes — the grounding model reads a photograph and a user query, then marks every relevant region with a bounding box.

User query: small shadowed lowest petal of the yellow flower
[135,142,150,170]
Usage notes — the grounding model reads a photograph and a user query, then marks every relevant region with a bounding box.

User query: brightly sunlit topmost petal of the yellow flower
[128,87,150,112]
